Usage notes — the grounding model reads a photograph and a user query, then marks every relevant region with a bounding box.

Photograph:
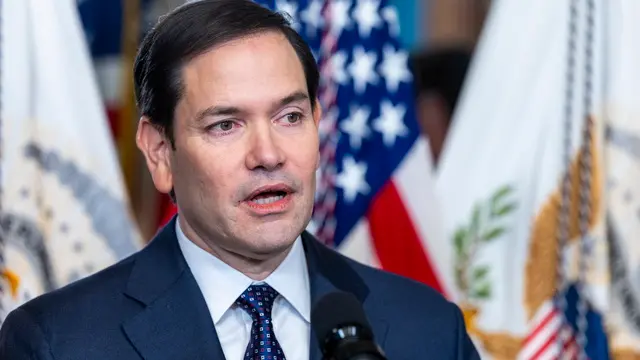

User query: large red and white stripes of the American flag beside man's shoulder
[339,138,456,300]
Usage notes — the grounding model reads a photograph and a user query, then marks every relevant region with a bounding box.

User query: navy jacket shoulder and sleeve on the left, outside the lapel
[0,248,151,359]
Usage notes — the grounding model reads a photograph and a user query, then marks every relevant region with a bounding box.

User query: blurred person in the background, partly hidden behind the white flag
[411,47,471,168]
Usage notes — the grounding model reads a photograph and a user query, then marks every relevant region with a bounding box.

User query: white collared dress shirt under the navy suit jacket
[176,221,311,360]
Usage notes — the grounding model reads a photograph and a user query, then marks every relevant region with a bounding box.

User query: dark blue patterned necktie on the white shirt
[236,284,286,360]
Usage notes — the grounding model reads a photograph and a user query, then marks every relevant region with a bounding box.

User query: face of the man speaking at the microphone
[140,32,320,258]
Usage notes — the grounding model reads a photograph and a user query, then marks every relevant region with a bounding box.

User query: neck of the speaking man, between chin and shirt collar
[178,217,293,281]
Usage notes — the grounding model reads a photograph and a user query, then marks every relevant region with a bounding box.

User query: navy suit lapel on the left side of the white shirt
[123,217,224,360]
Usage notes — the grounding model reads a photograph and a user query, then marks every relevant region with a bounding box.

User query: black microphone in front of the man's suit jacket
[311,292,387,360]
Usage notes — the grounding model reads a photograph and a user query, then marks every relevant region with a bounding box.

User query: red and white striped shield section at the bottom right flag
[518,301,580,360]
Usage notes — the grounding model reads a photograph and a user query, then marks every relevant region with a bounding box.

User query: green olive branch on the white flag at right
[453,185,516,302]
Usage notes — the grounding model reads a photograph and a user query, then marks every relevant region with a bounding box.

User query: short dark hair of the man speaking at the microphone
[134,0,319,149]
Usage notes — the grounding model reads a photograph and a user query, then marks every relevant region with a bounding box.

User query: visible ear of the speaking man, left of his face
[136,116,173,194]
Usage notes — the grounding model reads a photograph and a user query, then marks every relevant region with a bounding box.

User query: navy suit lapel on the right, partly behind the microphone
[302,231,388,360]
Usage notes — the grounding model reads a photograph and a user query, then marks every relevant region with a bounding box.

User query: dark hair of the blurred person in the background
[410,48,472,118]
